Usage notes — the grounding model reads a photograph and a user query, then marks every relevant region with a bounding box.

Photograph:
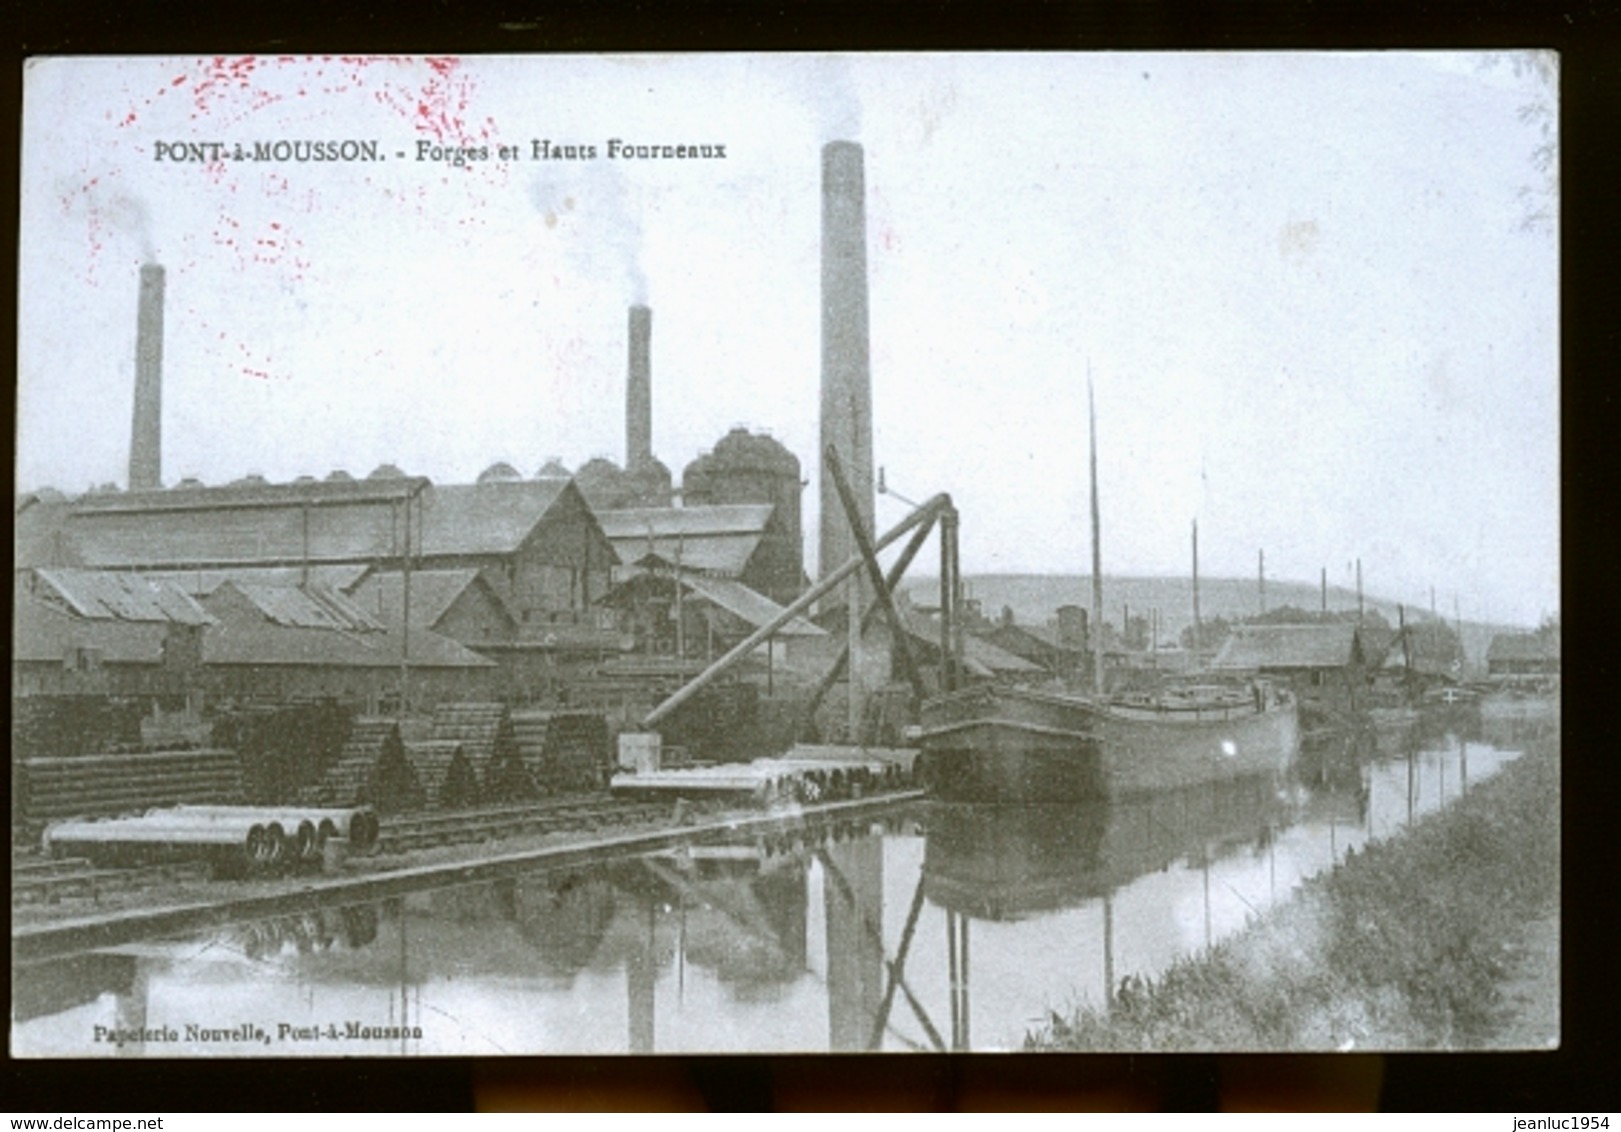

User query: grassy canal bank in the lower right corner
[1028,723,1559,1051]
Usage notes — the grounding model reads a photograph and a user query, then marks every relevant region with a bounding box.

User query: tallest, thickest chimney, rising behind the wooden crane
[817,141,874,577]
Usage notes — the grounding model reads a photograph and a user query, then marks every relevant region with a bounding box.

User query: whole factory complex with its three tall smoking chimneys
[15,128,874,726]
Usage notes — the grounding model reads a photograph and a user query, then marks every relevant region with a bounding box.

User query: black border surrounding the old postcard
[0,0,1621,1116]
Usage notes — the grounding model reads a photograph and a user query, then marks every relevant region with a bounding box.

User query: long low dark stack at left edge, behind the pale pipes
[15,748,242,827]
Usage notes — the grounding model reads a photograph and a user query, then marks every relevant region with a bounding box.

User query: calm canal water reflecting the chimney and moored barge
[11,717,1519,1057]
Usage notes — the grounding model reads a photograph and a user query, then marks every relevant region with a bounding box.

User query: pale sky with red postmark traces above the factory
[16,52,1559,624]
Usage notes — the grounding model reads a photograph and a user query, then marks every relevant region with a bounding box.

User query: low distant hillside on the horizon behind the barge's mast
[906,574,1533,665]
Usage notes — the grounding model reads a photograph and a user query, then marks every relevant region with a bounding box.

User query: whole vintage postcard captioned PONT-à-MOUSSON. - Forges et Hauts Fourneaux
[10,52,1561,1057]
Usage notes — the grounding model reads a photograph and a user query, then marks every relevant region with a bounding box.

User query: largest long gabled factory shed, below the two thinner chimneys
[18,469,618,647]
